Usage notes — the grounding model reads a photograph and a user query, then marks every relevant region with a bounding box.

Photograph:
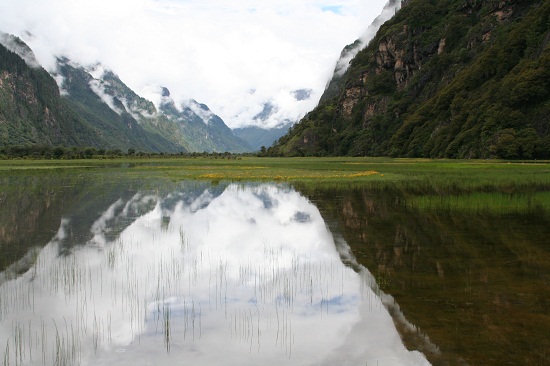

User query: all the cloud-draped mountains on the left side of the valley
[0,34,252,153]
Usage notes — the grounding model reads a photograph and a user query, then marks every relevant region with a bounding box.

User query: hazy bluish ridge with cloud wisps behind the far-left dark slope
[55,60,251,152]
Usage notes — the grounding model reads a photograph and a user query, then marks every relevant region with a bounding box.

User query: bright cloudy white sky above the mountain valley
[0,0,387,128]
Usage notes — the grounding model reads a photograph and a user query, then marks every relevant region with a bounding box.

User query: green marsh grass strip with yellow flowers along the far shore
[0,157,550,190]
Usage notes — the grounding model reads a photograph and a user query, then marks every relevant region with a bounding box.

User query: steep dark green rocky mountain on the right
[268,0,550,159]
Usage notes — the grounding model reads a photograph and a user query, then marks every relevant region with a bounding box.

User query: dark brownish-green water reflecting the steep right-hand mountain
[307,187,550,365]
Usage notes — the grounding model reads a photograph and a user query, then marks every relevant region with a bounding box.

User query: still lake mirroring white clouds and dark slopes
[0,169,550,365]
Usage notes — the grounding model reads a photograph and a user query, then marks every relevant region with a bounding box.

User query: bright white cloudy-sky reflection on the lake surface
[0,185,428,365]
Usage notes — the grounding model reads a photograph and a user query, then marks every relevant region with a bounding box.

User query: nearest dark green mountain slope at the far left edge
[0,34,103,147]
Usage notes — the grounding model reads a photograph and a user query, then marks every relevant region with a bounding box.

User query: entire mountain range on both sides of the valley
[0,0,550,159]
